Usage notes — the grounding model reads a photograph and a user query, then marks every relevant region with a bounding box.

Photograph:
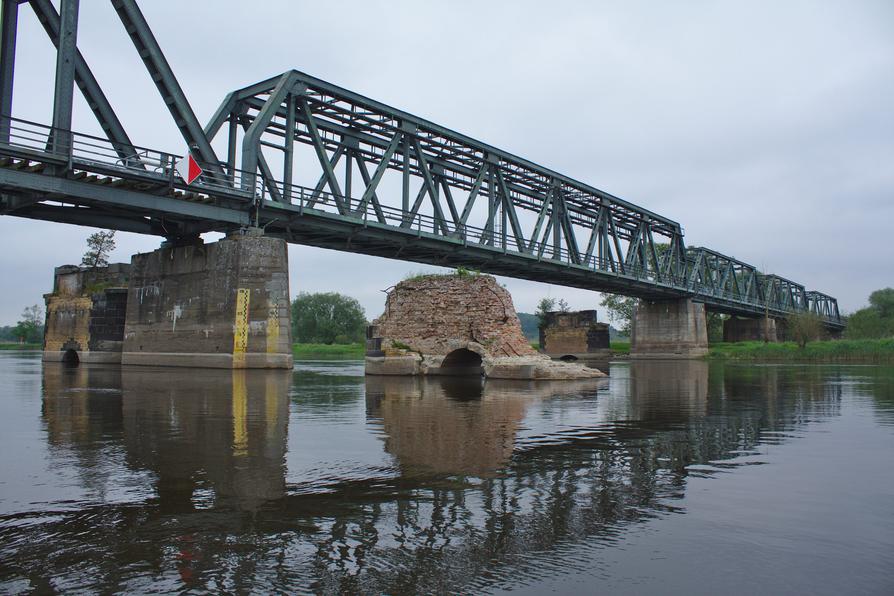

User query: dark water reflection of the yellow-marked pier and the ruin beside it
[43,365,290,512]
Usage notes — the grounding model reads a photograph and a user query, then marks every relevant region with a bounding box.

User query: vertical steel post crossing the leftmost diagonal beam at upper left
[51,0,80,153]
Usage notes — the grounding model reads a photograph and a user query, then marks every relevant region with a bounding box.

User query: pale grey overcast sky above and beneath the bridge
[0,0,894,324]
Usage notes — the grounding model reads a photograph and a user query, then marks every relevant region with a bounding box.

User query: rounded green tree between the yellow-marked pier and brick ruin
[292,292,366,344]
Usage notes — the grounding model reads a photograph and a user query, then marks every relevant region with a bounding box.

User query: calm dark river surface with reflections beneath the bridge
[0,353,894,594]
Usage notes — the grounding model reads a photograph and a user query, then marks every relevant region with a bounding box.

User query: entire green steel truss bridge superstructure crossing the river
[0,0,843,329]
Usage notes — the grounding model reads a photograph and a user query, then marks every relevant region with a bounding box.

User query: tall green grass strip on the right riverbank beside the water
[708,339,894,364]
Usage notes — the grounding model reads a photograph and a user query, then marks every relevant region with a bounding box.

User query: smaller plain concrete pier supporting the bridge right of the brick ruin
[630,298,708,359]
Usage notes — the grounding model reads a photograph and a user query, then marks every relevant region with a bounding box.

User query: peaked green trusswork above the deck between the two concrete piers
[204,71,685,280]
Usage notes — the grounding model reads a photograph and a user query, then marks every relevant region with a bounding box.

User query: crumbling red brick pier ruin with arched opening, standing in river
[366,275,604,379]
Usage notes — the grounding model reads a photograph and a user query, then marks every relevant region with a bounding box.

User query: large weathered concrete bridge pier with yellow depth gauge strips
[121,228,292,368]
